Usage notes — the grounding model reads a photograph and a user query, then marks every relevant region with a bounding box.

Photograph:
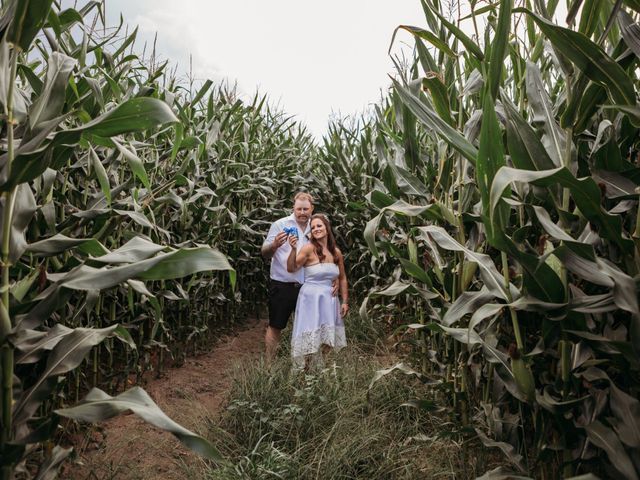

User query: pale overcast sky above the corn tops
[94,0,425,137]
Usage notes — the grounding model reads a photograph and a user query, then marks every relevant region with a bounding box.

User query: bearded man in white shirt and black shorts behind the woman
[261,192,313,362]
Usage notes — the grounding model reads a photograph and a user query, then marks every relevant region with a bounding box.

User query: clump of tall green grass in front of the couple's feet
[196,347,484,479]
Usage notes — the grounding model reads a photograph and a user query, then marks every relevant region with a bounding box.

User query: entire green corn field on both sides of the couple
[0,0,640,480]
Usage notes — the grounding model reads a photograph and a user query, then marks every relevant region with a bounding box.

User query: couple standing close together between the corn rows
[261,192,349,367]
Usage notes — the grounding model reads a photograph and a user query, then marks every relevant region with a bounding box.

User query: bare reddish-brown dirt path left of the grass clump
[61,321,266,480]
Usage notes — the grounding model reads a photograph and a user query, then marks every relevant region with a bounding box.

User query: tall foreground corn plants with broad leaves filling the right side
[365,0,640,479]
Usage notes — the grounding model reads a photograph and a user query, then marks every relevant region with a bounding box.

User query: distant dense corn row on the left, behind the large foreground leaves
[17,0,315,398]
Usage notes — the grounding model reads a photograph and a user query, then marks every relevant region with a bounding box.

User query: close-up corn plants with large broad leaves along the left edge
[0,0,240,479]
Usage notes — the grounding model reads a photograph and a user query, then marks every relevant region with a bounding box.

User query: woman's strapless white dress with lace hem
[291,263,347,366]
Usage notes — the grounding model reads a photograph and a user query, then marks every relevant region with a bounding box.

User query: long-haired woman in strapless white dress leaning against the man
[287,214,349,367]
